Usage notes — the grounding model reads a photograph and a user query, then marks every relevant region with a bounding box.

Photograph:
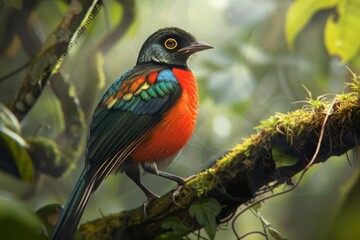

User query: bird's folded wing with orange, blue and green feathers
[87,65,182,180]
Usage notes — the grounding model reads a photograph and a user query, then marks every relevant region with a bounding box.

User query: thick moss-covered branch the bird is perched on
[80,77,360,240]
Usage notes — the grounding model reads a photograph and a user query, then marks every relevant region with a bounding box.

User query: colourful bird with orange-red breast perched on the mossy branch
[51,27,213,240]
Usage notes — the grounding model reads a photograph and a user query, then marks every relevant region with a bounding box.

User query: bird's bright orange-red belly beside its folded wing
[130,93,197,162]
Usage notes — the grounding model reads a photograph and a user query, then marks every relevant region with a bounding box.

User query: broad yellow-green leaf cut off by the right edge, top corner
[325,0,360,62]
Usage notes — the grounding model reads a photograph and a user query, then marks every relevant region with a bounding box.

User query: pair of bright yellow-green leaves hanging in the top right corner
[285,0,360,62]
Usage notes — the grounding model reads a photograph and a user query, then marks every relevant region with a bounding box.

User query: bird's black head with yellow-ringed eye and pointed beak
[136,27,212,66]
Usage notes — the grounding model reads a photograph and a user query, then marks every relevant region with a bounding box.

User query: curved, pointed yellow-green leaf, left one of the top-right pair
[285,0,341,50]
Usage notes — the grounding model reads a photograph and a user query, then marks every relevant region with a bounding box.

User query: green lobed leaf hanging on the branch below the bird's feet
[189,198,221,239]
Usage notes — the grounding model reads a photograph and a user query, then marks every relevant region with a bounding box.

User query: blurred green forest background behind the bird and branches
[0,0,360,240]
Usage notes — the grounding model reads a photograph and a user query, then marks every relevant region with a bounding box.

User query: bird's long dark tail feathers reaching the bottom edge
[50,169,95,240]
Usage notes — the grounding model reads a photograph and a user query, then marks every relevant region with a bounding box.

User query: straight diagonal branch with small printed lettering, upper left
[9,0,97,120]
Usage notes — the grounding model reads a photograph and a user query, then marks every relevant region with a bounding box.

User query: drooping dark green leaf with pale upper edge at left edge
[0,122,34,183]
